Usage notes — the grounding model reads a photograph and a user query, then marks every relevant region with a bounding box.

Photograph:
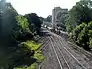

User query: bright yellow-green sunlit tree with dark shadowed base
[15,15,33,41]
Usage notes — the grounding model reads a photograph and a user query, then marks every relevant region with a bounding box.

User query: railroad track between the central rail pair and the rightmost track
[52,35,87,69]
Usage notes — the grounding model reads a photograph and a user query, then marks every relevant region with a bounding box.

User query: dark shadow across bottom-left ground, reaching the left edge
[0,45,37,69]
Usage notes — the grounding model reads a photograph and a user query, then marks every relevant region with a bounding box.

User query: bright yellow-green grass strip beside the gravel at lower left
[14,40,44,69]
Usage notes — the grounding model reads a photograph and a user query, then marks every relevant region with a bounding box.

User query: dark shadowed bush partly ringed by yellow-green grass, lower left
[8,44,36,69]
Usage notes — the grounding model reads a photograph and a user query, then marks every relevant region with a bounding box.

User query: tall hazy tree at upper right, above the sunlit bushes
[66,0,92,32]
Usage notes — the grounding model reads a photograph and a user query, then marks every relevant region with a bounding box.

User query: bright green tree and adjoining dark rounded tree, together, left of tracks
[15,13,42,40]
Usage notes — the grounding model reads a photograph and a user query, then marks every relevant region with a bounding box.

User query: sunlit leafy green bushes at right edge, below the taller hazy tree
[72,22,92,50]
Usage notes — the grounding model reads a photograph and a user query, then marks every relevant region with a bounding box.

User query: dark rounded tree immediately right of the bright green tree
[25,13,42,34]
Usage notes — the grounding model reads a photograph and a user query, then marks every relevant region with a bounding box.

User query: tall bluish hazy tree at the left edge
[0,0,18,44]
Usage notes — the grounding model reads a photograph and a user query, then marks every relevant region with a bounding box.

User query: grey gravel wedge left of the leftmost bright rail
[39,37,61,69]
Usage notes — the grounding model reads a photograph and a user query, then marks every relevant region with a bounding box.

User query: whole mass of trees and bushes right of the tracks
[66,0,92,50]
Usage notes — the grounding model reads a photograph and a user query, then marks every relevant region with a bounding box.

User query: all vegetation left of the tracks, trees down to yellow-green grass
[0,0,44,69]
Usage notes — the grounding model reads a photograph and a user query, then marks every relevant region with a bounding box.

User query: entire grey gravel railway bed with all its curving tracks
[39,30,92,69]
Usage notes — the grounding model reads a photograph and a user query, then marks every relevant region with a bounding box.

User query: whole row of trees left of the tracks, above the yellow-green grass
[0,0,42,43]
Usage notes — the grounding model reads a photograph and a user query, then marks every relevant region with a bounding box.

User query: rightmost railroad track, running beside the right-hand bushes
[60,38,92,69]
